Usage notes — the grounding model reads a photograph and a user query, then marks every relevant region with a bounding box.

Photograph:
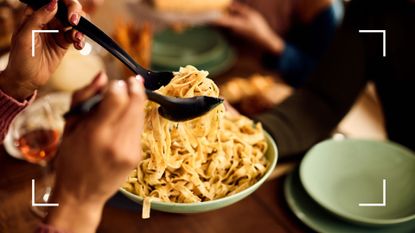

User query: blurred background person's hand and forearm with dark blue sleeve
[215,0,337,87]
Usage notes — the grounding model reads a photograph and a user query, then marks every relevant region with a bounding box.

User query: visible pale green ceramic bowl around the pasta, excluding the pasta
[120,133,278,213]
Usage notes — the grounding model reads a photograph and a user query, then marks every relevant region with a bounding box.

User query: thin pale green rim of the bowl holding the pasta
[119,130,278,208]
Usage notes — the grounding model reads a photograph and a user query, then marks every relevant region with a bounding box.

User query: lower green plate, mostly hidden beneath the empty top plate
[284,171,415,233]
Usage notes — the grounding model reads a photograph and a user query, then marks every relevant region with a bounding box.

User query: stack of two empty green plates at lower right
[285,139,415,233]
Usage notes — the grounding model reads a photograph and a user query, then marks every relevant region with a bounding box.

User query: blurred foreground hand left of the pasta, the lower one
[47,74,146,232]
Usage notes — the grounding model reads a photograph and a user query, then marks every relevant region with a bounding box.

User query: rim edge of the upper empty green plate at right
[299,138,415,226]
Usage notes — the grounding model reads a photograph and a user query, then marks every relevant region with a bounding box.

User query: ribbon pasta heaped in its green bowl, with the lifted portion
[121,66,277,218]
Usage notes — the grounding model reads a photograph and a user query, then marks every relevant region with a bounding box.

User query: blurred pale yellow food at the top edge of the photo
[151,0,232,13]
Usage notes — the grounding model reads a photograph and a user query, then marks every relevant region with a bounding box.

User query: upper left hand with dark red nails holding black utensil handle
[0,0,84,101]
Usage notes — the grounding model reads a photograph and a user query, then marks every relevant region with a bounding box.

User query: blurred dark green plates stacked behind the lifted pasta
[152,27,235,76]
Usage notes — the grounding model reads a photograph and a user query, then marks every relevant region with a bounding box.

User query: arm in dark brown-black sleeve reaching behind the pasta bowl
[256,1,368,157]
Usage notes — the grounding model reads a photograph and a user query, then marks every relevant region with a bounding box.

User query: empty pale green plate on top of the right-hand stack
[300,139,415,225]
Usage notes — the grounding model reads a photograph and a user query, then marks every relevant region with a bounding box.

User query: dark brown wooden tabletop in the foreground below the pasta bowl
[0,148,310,233]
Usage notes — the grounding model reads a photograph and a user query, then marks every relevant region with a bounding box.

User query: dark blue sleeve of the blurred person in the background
[263,6,336,87]
